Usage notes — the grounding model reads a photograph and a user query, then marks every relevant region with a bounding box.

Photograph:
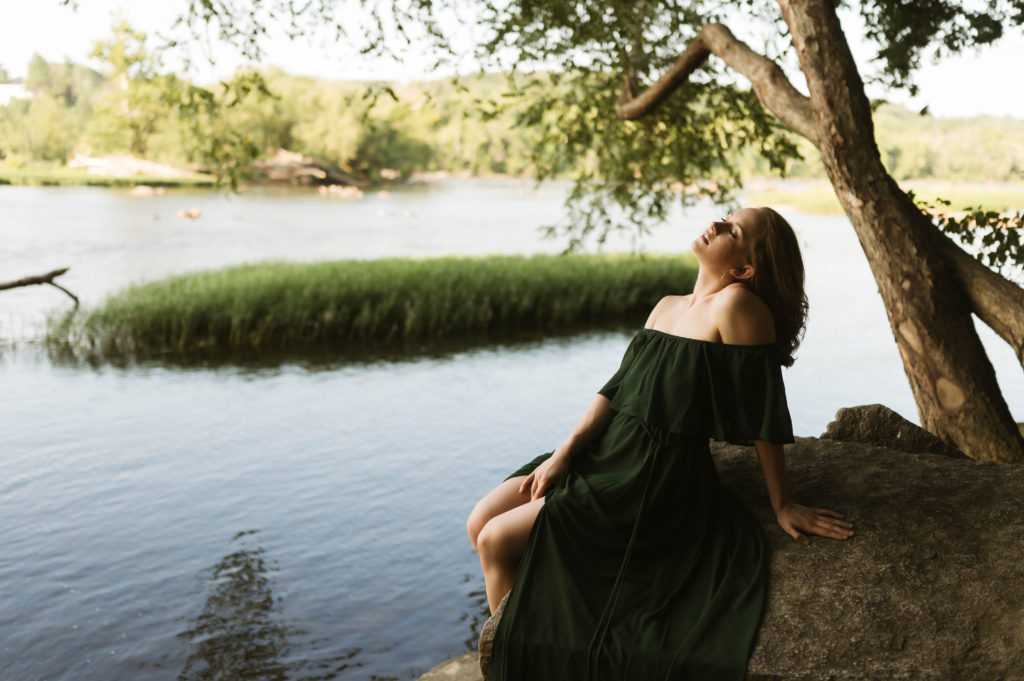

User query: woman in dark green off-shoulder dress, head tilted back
[467,208,853,681]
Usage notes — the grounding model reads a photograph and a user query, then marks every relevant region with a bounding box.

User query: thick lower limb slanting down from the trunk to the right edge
[937,232,1024,367]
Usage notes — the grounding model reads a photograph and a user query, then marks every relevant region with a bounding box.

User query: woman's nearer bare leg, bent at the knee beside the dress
[476,497,544,614]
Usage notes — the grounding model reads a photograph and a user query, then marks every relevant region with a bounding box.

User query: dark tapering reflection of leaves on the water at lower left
[178,530,290,681]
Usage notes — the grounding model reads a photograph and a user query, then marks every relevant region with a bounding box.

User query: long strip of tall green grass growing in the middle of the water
[54,254,696,355]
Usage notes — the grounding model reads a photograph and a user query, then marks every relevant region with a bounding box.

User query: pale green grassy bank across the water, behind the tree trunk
[744,183,1024,214]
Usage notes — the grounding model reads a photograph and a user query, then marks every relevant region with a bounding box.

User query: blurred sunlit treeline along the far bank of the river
[0,24,1024,181]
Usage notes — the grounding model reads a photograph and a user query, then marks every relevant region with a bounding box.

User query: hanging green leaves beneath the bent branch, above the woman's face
[503,70,796,250]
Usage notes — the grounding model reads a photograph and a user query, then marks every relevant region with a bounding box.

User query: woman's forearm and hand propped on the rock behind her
[754,440,853,546]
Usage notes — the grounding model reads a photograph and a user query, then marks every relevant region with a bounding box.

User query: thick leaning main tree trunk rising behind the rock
[779,0,1024,462]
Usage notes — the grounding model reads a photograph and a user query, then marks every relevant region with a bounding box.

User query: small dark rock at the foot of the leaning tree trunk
[821,405,967,457]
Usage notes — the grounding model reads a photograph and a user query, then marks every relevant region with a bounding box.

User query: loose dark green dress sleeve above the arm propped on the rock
[709,346,794,444]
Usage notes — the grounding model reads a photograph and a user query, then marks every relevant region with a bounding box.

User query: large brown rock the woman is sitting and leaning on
[423,438,1024,681]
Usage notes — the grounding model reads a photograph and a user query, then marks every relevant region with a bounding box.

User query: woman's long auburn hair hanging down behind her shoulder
[749,206,807,367]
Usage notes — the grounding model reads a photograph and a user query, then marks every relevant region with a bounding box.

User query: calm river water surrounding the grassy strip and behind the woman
[0,181,1024,681]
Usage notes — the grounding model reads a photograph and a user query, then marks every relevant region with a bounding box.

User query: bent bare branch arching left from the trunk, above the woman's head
[615,24,818,145]
